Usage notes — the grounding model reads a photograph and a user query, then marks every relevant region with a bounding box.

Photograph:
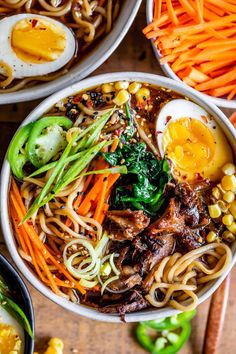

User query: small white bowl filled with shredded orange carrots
[143,0,236,108]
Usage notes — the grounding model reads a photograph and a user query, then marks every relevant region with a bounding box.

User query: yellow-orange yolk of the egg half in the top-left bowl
[11,18,66,64]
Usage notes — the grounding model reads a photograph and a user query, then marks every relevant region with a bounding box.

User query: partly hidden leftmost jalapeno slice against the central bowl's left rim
[8,123,34,180]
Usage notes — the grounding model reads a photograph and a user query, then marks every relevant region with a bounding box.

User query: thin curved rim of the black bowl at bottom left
[0,253,35,354]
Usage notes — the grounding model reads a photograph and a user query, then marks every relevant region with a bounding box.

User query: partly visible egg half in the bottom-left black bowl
[0,306,24,354]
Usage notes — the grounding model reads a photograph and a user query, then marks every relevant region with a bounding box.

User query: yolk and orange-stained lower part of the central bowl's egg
[162,118,233,181]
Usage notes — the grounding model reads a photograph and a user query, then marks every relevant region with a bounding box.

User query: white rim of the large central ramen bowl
[1,72,236,322]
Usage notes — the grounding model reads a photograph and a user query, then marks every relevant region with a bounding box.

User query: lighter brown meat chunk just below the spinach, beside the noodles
[107,209,150,241]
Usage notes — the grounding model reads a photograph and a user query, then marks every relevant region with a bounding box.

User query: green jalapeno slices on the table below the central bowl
[136,310,196,354]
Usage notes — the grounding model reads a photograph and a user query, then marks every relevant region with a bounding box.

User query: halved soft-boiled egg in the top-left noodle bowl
[0,14,76,79]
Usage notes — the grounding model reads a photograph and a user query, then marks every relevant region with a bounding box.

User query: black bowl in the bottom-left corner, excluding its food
[0,254,34,354]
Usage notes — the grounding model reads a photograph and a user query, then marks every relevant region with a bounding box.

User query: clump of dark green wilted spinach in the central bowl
[104,143,170,215]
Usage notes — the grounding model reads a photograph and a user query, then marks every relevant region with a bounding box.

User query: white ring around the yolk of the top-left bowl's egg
[0,14,75,79]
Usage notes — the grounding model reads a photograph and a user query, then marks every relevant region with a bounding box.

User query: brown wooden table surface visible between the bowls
[0,2,236,354]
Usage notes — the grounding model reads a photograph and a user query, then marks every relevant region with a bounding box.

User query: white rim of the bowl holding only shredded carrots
[146,0,236,109]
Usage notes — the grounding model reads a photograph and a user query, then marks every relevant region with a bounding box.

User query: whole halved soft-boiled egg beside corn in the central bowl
[156,99,233,181]
